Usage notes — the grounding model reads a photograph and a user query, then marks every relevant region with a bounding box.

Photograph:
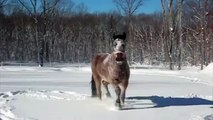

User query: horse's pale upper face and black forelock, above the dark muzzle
[113,32,126,52]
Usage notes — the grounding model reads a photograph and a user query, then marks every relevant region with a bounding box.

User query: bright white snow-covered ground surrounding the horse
[0,64,213,120]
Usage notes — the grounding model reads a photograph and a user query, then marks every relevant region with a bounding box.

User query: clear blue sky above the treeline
[72,0,161,14]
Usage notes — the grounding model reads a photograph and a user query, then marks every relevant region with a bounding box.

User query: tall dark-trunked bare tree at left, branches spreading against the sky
[18,0,60,67]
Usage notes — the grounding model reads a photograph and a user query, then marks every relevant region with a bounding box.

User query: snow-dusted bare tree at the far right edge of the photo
[185,0,213,69]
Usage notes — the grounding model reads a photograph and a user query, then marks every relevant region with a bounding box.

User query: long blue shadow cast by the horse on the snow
[123,96,213,110]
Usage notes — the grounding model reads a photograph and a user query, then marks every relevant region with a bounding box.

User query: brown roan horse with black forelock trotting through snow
[91,33,130,108]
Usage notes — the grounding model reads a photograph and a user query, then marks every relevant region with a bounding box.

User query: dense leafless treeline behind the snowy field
[0,0,213,69]
